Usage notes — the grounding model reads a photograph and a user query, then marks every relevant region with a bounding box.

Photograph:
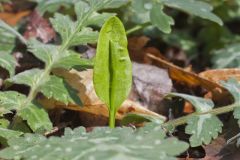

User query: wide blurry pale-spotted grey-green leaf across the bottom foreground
[0,124,188,160]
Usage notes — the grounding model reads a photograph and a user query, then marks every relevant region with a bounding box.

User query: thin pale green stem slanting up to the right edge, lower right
[163,103,239,127]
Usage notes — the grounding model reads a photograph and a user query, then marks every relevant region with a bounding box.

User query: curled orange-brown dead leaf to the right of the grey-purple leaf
[147,54,237,109]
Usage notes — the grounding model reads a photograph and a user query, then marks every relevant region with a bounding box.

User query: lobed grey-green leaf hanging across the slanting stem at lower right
[169,93,223,147]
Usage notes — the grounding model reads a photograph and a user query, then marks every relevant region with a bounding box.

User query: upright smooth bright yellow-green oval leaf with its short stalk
[93,16,132,128]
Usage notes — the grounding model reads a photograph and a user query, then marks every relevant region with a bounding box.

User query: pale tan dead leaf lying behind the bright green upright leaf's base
[39,69,166,123]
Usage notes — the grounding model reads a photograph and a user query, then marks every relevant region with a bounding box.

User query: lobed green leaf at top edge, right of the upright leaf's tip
[129,0,223,33]
